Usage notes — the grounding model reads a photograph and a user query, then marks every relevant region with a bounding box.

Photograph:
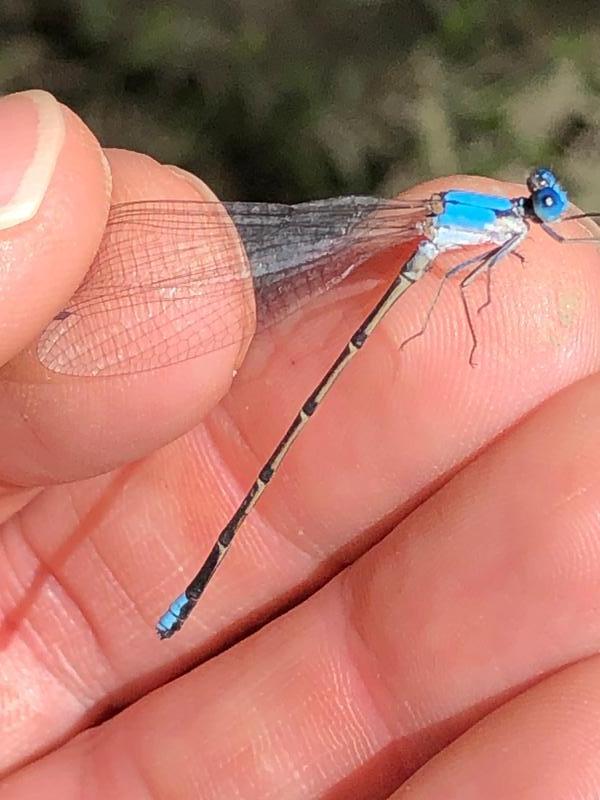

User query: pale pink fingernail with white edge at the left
[0,89,65,230]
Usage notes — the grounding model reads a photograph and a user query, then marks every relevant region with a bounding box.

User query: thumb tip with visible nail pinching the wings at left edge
[0,90,110,365]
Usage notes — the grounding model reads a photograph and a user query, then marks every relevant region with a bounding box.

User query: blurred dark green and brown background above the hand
[0,0,600,207]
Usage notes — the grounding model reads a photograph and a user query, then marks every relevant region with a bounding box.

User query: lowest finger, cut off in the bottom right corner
[390,656,600,800]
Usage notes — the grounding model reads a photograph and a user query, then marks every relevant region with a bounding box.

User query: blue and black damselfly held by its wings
[37,168,598,638]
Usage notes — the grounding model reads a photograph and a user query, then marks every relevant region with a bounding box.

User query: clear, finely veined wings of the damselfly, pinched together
[37,197,430,376]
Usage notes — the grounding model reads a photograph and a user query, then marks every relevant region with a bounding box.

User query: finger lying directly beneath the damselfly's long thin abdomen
[0,170,600,776]
